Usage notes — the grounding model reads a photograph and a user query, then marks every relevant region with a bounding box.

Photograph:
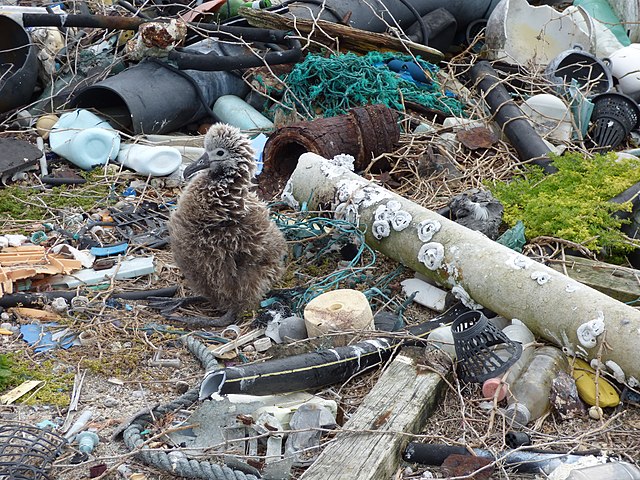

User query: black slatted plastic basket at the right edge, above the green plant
[589,93,640,151]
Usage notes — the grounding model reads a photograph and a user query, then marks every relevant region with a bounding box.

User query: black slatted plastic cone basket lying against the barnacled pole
[451,311,522,383]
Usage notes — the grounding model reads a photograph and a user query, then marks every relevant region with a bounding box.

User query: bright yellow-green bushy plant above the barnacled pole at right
[487,153,640,256]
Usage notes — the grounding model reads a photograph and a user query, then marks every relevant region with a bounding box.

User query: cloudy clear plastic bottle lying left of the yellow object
[506,346,569,425]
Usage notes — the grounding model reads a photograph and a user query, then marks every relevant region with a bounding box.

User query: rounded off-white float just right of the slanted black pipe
[520,93,573,142]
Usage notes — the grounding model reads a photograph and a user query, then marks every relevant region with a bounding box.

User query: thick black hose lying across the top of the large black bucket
[169,38,302,72]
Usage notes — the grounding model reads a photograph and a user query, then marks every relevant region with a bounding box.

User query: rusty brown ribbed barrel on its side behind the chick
[259,105,400,197]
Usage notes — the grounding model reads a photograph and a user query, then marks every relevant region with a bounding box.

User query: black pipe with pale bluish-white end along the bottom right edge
[402,442,584,474]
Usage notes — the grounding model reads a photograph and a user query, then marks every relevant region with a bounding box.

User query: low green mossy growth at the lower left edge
[0,351,74,407]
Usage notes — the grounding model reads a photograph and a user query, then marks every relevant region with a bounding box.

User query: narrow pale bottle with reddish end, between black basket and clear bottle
[482,321,535,401]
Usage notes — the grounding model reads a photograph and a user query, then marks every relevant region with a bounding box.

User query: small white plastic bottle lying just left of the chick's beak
[117,144,182,177]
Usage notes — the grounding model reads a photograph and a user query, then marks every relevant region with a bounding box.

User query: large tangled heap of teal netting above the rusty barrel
[270,52,464,118]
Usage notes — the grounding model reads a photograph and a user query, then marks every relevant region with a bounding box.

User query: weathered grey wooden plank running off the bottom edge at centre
[301,352,444,480]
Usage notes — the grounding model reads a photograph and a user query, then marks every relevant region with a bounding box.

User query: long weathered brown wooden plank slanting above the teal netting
[238,8,444,63]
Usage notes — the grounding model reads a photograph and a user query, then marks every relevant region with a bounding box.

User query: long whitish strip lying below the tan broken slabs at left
[48,256,155,288]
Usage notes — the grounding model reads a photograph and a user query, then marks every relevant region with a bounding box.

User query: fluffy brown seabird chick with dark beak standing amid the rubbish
[168,123,287,326]
